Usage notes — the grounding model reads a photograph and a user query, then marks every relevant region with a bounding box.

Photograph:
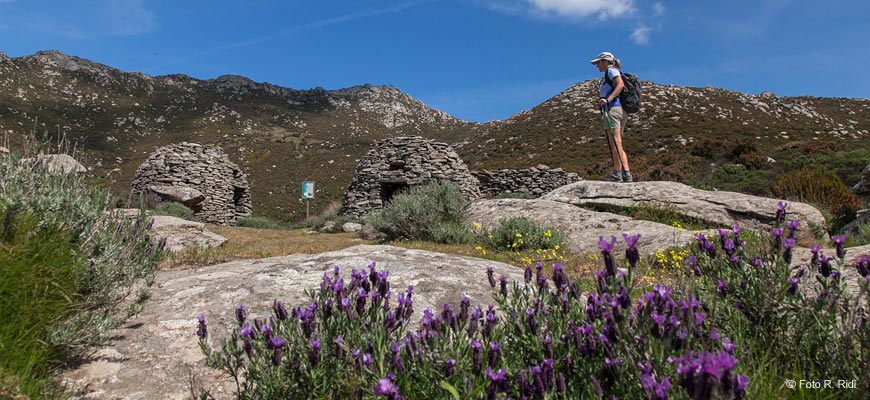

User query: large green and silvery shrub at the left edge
[0,146,164,398]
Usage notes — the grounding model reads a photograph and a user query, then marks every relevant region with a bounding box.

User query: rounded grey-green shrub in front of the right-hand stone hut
[368,181,469,240]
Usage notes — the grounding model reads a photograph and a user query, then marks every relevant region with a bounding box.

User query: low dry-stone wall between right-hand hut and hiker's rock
[471,165,580,197]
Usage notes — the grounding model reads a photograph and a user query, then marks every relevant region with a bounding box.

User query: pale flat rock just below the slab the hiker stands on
[463,199,694,254]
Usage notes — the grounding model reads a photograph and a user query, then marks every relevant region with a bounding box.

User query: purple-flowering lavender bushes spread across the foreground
[198,205,870,399]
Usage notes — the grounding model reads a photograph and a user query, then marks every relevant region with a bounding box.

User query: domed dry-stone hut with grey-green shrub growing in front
[340,136,480,217]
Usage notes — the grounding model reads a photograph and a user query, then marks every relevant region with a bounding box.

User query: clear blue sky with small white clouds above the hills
[0,0,870,121]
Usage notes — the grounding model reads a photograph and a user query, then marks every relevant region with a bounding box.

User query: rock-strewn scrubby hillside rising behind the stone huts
[0,51,870,219]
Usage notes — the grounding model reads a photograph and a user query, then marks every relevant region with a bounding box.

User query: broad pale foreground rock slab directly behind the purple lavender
[64,245,523,400]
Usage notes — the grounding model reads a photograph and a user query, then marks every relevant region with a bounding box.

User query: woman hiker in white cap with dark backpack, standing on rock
[590,51,632,182]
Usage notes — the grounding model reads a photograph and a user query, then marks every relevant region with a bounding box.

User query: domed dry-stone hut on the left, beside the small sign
[133,142,252,225]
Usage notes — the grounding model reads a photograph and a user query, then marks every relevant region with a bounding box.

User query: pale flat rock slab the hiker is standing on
[541,181,825,245]
